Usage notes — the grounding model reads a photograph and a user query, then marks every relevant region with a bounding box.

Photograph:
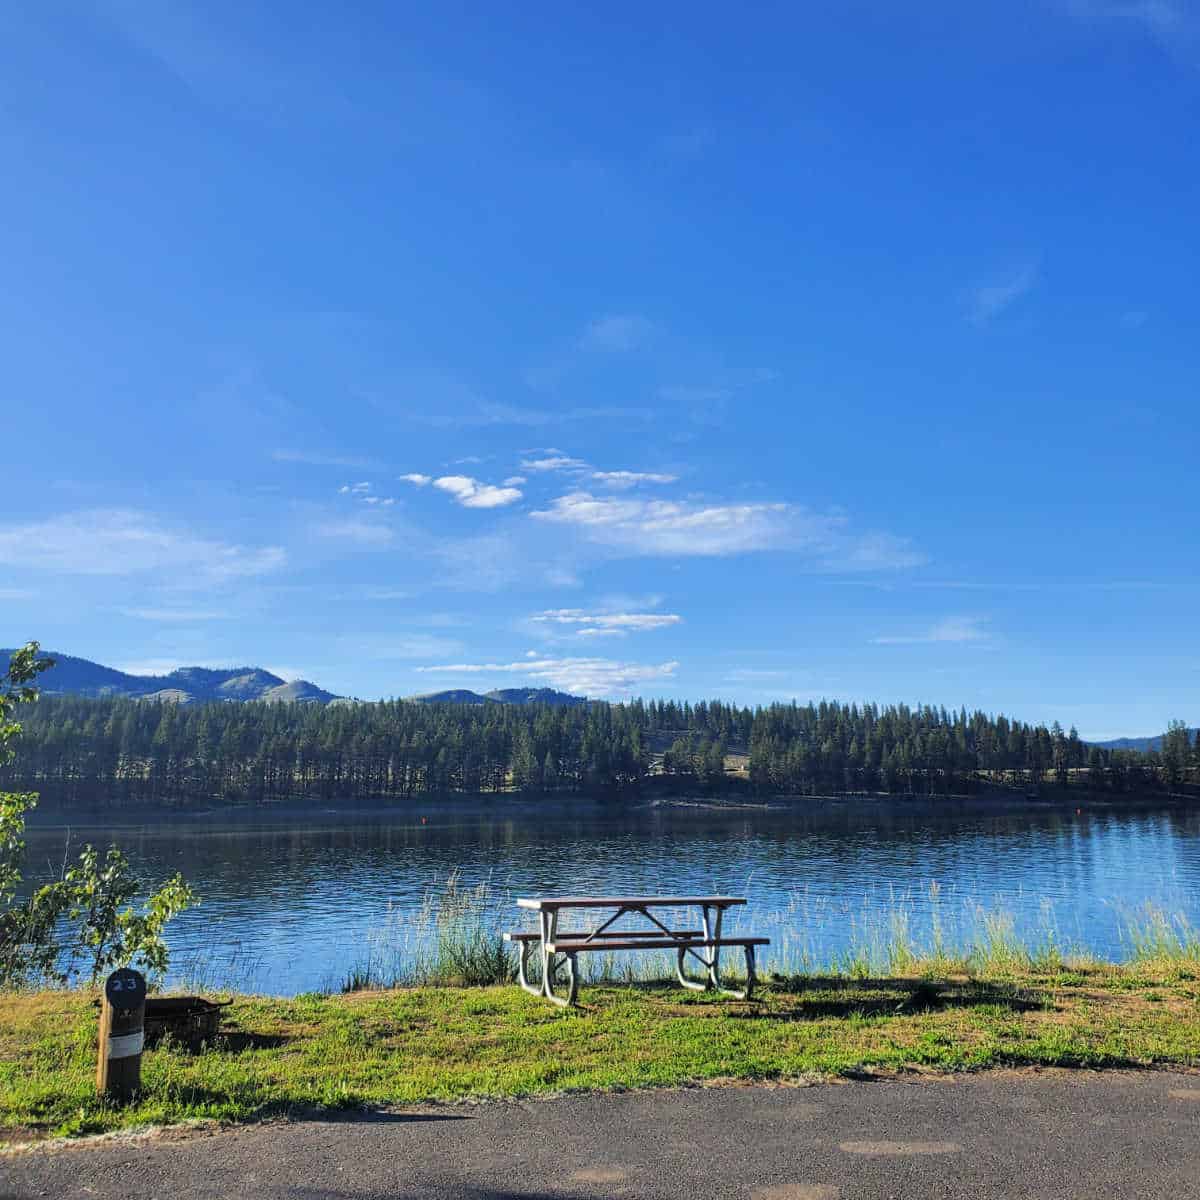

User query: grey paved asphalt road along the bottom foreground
[0,1072,1200,1200]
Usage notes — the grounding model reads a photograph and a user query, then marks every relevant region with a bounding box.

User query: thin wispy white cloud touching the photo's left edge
[0,509,287,582]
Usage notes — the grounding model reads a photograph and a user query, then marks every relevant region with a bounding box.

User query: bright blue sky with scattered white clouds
[0,0,1200,737]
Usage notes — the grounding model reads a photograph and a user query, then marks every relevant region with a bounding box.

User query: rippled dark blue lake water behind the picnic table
[28,803,1200,994]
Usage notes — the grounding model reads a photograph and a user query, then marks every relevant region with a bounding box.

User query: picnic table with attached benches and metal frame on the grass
[504,895,770,1007]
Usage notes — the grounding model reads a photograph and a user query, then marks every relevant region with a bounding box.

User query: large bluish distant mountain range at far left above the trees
[0,650,337,704]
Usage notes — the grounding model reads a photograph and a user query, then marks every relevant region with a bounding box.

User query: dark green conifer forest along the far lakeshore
[0,696,1200,806]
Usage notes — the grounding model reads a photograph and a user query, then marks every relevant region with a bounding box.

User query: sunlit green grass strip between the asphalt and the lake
[0,960,1200,1142]
